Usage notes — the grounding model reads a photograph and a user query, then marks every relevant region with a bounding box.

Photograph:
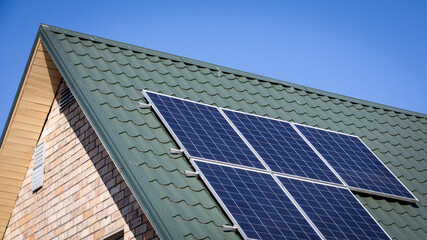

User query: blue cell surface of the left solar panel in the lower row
[195,161,320,240]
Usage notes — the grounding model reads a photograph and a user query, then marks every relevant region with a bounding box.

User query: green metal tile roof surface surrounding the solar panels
[39,25,427,239]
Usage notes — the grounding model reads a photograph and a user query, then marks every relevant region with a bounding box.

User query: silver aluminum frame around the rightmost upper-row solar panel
[293,123,419,203]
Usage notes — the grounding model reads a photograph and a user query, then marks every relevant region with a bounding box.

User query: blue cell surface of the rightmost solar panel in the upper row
[296,125,414,199]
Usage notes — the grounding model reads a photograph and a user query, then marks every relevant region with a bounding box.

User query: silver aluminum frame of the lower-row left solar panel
[190,159,326,240]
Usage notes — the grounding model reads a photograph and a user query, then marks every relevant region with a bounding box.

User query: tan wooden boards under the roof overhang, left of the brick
[0,39,61,239]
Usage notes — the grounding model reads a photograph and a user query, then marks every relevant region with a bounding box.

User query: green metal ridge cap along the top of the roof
[40,23,427,119]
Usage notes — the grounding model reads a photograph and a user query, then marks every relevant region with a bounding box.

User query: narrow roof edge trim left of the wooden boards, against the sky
[0,26,41,148]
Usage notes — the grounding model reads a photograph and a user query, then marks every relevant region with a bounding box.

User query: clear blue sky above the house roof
[0,0,427,131]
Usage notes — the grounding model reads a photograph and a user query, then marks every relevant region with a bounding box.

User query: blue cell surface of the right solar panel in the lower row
[279,177,389,239]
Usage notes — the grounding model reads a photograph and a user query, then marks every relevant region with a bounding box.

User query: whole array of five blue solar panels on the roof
[145,91,416,239]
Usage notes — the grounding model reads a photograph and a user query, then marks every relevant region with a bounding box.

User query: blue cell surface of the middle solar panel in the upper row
[223,110,342,184]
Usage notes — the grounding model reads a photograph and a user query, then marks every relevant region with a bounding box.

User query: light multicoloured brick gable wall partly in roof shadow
[4,83,157,240]
